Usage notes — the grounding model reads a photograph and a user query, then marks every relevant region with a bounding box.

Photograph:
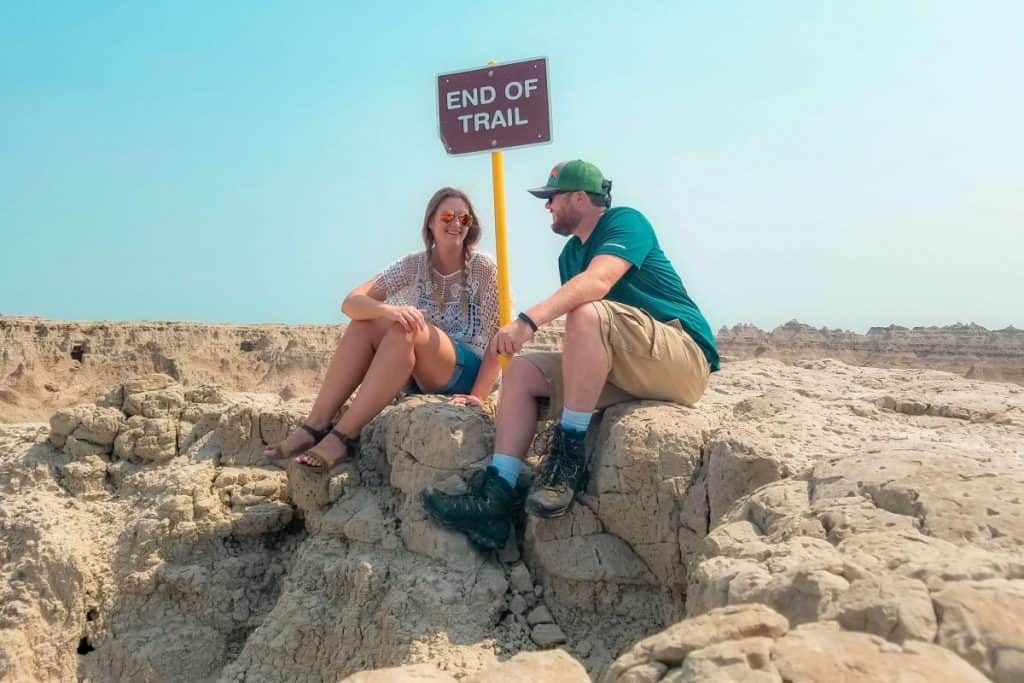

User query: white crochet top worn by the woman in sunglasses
[378,251,498,357]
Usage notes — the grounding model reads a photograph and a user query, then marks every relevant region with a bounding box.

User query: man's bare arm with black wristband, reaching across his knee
[495,254,633,355]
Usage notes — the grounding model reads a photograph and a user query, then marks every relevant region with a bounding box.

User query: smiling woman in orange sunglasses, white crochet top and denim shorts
[263,187,499,474]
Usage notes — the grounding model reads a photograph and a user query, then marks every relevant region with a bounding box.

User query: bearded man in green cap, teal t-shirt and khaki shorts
[422,160,719,548]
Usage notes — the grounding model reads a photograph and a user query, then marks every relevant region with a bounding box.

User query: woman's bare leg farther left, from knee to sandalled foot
[265,319,391,454]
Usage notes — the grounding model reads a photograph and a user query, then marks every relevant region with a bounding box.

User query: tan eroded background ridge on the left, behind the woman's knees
[0,315,560,423]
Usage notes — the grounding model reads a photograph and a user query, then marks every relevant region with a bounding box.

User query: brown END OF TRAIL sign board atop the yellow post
[437,57,551,155]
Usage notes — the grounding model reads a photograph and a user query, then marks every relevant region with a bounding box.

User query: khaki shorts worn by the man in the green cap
[522,301,711,418]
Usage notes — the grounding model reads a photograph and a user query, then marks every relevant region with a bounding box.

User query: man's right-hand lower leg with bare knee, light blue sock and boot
[526,303,610,517]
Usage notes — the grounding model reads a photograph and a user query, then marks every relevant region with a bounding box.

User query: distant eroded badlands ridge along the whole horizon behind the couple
[0,315,1024,423]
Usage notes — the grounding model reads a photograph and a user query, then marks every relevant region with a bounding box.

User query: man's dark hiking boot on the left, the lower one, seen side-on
[420,466,518,550]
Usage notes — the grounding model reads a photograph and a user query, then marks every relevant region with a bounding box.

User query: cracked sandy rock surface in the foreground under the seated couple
[0,360,1024,681]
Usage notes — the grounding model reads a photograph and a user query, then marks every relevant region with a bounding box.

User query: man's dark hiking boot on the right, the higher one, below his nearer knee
[526,425,587,518]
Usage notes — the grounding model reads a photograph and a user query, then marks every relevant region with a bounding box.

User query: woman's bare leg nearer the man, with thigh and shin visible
[298,324,456,466]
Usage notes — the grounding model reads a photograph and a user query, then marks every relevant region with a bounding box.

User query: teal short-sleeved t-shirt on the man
[558,207,719,372]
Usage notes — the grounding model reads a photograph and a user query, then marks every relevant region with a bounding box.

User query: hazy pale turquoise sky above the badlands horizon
[0,0,1024,332]
